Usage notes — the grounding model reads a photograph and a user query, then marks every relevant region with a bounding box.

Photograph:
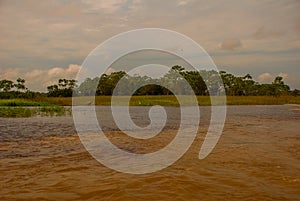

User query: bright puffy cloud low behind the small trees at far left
[0,64,80,91]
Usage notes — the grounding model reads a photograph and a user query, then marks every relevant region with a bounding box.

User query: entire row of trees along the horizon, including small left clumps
[0,65,300,99]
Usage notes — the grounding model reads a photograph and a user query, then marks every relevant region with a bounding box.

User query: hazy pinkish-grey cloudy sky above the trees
[0,0,300,91]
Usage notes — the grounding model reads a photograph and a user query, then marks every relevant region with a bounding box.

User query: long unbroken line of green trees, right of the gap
[76,65,300,96]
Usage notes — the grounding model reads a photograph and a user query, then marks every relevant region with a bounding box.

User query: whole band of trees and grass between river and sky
[0,65,300,112]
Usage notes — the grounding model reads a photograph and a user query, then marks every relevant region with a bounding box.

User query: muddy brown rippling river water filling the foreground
[0,105,300,201]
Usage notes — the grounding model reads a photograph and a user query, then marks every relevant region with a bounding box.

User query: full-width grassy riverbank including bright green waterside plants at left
[0,96,300,117]
